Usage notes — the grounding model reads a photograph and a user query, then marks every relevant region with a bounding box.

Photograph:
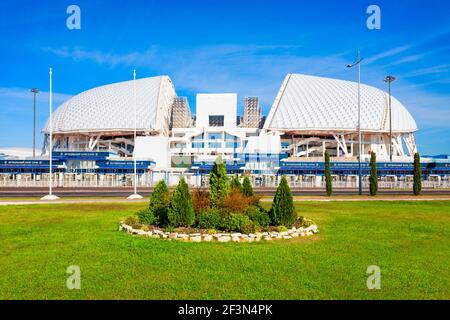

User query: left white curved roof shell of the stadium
[44,76,176,134]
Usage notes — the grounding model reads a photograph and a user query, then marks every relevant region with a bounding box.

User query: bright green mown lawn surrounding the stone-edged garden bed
[0,201,450,299]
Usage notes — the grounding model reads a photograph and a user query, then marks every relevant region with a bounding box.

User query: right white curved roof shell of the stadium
[264,74,417,133]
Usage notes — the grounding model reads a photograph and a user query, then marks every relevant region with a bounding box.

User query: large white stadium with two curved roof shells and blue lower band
[0,74,450,187]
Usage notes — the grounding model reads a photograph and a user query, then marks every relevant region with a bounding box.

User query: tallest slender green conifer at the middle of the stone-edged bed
[209,156,230,208]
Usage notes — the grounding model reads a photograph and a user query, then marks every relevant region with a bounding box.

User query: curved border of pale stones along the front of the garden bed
[119,222,319,242]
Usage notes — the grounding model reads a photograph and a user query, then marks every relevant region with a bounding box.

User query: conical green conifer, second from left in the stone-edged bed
[168,178,195,227]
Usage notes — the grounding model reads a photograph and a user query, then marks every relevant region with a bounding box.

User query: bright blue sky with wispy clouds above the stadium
[0,0,450,154]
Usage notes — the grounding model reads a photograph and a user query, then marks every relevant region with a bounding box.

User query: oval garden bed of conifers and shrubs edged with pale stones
[120,158,317,242]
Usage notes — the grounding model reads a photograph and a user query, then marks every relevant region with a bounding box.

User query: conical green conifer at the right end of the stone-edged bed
[270,176,296,227]
